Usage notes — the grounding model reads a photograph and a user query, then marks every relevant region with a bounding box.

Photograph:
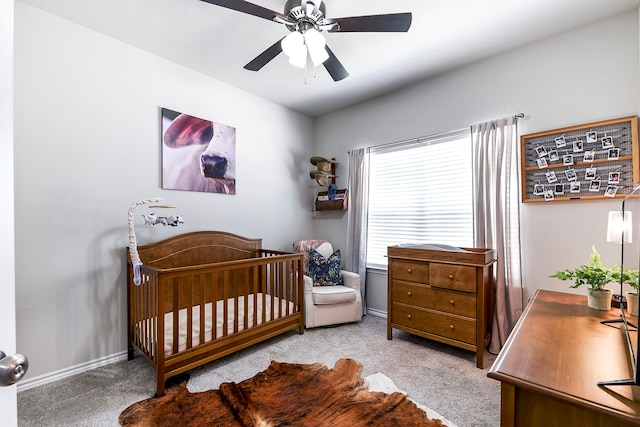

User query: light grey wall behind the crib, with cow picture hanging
[14,2,313,378]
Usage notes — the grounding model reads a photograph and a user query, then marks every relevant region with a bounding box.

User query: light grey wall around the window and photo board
[315,11,639,311]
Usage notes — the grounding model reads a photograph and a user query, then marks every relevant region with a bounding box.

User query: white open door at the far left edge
[0,0,18,426]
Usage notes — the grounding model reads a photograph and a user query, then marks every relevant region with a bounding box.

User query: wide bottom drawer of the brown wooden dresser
[391,302,476,345]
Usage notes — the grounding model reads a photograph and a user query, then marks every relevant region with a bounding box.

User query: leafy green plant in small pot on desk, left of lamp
[549,246,619,310]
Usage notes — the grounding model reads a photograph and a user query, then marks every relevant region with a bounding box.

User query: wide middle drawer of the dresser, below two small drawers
[391,280,476,318]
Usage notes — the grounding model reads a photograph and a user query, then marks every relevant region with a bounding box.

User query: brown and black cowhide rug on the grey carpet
[119,359,445,427]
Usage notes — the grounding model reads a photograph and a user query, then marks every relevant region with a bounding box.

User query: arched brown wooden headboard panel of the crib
[127,231,262,269]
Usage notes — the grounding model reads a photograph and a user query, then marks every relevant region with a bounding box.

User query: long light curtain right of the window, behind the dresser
[471,116,524,354]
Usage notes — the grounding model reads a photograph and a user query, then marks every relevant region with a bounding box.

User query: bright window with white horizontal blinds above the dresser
[367,130,473,269]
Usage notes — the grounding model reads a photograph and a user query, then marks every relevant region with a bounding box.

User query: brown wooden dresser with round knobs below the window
[387,245,496,368]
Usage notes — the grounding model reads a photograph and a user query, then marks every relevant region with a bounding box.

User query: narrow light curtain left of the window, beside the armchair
[345,148,369,314]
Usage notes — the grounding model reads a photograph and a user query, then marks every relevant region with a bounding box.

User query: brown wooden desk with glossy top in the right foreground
[488,290,640,427]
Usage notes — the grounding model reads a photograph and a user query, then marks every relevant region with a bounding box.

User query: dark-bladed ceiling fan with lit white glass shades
[201,0,411,82]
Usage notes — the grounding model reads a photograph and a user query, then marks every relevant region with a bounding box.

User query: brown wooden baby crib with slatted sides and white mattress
[126,231,304,396]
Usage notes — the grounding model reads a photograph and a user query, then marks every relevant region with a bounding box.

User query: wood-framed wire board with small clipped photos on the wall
[520,116,640,203]
